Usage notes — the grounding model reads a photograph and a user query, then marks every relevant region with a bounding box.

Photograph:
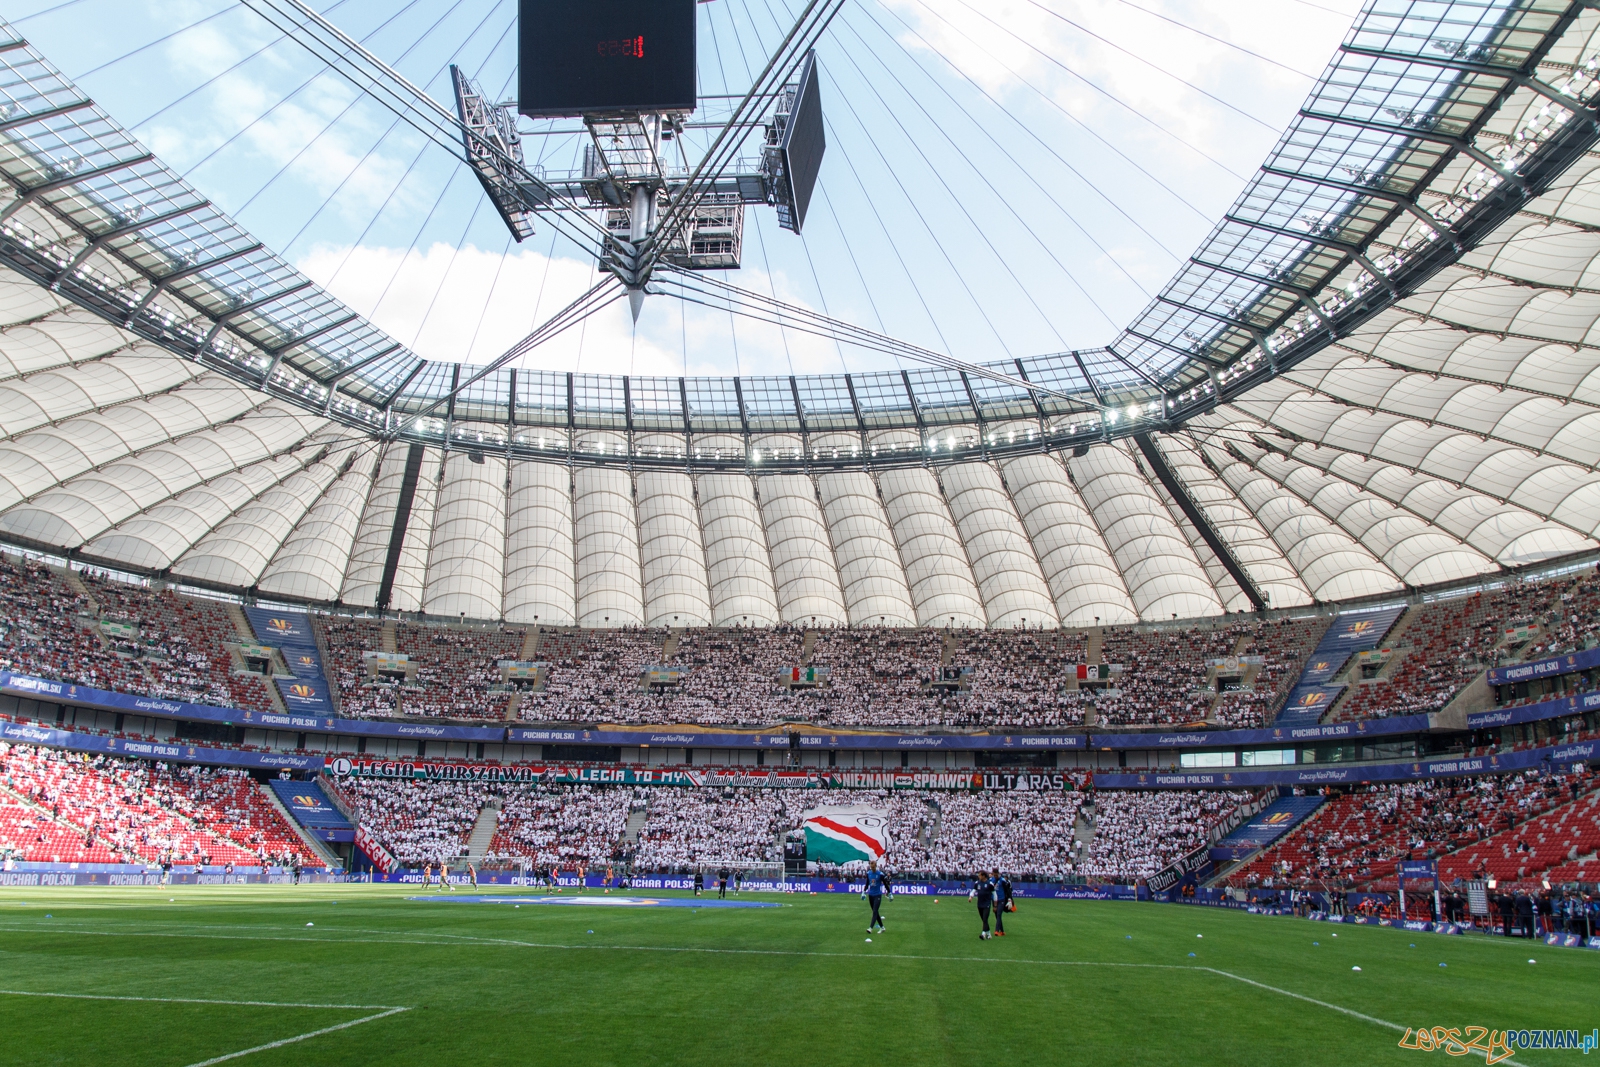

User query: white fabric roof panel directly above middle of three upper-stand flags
[878,467,987,627]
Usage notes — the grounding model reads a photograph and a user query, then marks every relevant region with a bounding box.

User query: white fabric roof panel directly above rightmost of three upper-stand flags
[1003,456,1139,625]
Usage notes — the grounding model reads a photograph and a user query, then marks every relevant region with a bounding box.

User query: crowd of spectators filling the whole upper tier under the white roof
[9,557,1600,729]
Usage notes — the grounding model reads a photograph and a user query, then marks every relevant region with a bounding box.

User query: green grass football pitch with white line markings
[0,886,1600,1067]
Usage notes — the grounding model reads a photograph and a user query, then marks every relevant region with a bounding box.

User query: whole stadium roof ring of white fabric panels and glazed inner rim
[0,0,1600,625]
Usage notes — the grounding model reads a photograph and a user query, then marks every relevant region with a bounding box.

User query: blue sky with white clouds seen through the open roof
[5,0,1360,376]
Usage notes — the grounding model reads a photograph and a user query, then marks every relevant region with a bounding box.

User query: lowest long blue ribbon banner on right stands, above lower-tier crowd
[1094,741,1600,789]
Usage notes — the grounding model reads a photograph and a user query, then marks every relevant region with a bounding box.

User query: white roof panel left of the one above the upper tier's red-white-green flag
[698,474,778,625]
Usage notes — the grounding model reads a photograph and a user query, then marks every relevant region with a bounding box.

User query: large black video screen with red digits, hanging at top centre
[517,0,696,118]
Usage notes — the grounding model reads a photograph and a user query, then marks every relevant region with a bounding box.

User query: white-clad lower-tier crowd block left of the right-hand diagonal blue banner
[1078,789,1250,881]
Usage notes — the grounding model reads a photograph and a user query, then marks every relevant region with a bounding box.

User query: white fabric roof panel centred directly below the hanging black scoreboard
[573,467,645,629]
